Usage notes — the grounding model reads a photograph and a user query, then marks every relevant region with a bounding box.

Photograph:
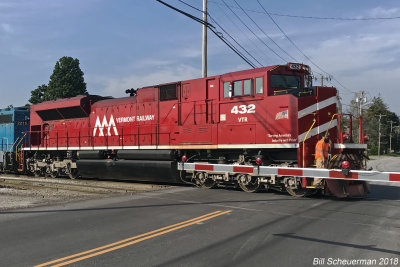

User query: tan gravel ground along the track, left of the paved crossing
[0,175,170,210]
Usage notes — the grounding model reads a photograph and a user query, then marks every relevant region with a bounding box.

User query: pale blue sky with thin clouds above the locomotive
[0,0,400,115]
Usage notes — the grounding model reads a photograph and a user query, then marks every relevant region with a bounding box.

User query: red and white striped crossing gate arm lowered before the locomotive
[178,162,400,182]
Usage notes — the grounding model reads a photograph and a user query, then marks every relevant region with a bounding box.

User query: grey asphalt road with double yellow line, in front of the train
[0,175,400,266]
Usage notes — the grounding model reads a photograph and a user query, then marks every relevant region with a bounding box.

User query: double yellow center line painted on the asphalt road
[35,210,231,267]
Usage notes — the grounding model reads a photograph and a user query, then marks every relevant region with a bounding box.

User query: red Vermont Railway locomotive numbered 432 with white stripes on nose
[24,63,367,195]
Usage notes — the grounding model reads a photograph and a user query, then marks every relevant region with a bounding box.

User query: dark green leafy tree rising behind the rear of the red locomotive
[29,57,87,104]
